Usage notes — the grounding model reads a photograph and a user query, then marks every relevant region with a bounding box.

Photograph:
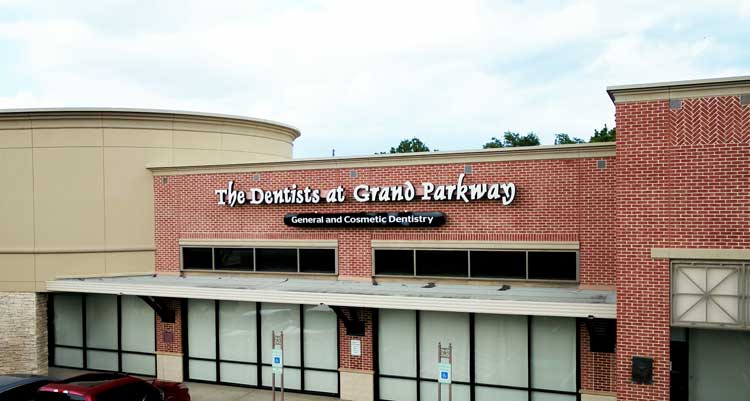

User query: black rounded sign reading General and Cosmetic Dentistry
[284,212,445,228]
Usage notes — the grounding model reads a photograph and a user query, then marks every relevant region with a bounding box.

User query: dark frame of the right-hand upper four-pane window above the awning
[372,246,581,284]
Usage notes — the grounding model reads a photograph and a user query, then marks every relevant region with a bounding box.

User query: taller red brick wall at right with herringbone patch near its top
[615,96,750,400]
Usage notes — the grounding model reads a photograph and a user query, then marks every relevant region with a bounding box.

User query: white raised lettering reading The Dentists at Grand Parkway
[214,174,516,207]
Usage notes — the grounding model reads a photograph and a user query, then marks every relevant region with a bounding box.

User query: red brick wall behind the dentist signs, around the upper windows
[154,157,615,285]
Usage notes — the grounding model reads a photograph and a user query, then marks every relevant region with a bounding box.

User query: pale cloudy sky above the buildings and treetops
[0,0,750,157]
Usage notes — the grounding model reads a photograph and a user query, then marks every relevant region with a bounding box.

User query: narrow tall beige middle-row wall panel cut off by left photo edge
[0,149,34,249]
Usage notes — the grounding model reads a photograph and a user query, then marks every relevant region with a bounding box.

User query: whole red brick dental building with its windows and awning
[39,78,750,401]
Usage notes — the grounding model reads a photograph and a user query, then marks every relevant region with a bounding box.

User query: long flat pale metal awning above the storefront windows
[47,275,616,319]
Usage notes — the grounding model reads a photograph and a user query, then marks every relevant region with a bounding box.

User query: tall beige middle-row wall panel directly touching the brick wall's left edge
[104,148,169,248]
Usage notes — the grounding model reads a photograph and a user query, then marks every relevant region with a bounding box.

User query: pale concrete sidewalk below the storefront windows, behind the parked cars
[49,367,338,401]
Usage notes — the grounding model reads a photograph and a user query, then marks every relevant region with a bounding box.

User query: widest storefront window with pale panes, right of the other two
[376,310,578,401]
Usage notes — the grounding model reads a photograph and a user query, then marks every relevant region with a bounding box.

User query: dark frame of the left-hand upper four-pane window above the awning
[180,244,339,276]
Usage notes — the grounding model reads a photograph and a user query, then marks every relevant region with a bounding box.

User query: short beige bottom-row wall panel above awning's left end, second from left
[36,253,106,282]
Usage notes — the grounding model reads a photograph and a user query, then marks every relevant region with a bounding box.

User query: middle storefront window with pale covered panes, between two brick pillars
[185,299,338,394]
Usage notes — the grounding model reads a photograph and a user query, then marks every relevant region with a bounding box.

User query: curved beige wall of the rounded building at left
[0,109,299,291]
